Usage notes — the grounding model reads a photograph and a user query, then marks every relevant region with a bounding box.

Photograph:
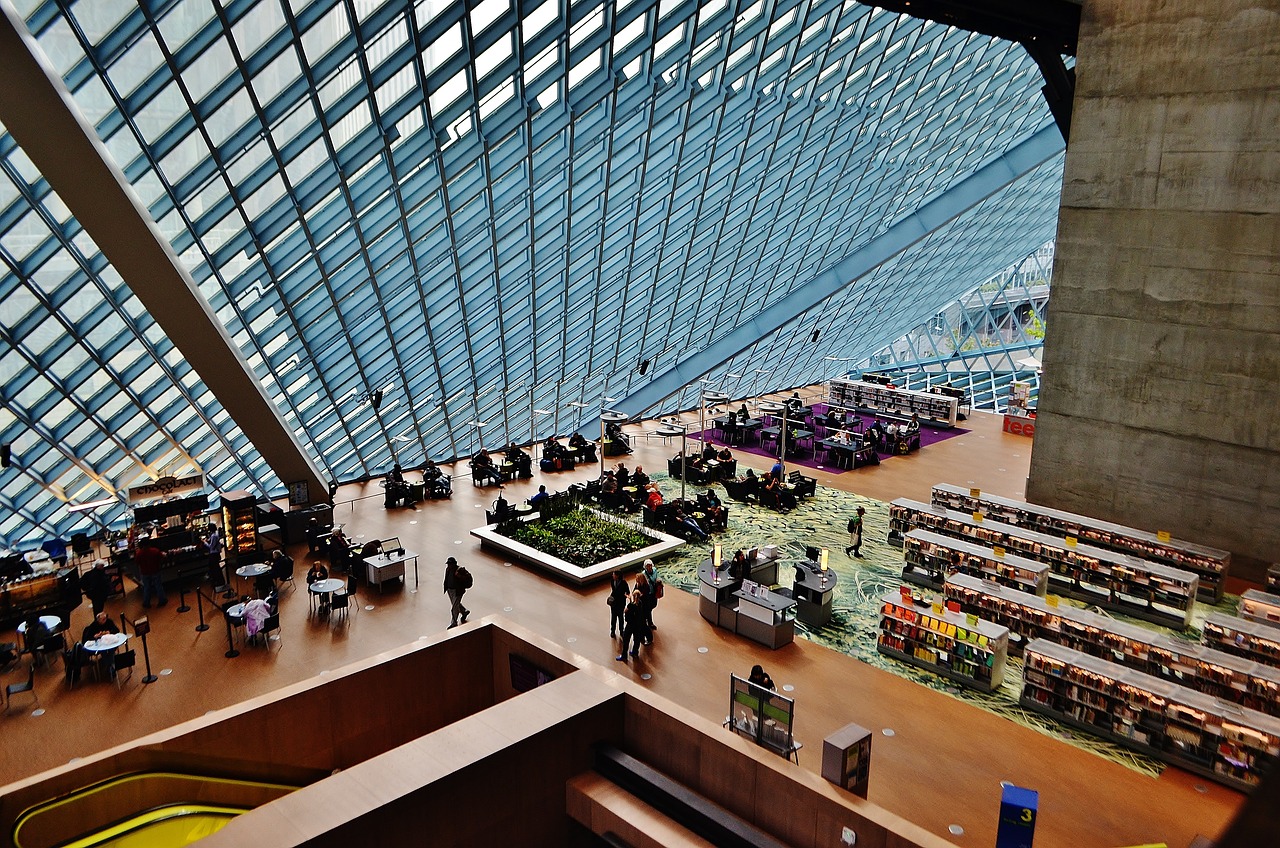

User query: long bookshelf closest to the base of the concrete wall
[931,483,1228,603]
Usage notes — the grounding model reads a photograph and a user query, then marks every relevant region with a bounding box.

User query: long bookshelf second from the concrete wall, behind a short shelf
[890,498,1198,630]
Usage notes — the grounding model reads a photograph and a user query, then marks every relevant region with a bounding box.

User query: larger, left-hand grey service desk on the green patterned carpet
[698,555,796,648]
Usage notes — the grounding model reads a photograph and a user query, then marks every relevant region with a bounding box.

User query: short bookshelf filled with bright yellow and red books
[876,593,1009,692]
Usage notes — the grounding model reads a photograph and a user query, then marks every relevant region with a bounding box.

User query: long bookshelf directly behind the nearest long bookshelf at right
[946,574,1280,716]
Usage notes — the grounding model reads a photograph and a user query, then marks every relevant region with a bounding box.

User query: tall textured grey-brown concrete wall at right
[1027,0,1280,573]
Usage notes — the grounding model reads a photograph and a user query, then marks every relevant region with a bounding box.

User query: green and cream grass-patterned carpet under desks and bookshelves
[654,474,1239,775]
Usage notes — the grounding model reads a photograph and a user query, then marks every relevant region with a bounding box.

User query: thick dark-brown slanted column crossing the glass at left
[0,0,328,501]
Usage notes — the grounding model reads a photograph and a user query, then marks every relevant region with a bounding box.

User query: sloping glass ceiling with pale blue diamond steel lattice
[0,0,1062,543]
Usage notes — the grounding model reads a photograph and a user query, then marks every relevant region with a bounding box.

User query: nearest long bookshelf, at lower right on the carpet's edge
[1019,639,1280,790]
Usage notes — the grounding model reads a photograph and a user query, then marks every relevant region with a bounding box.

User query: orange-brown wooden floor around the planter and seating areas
[0,402,1243,848]
